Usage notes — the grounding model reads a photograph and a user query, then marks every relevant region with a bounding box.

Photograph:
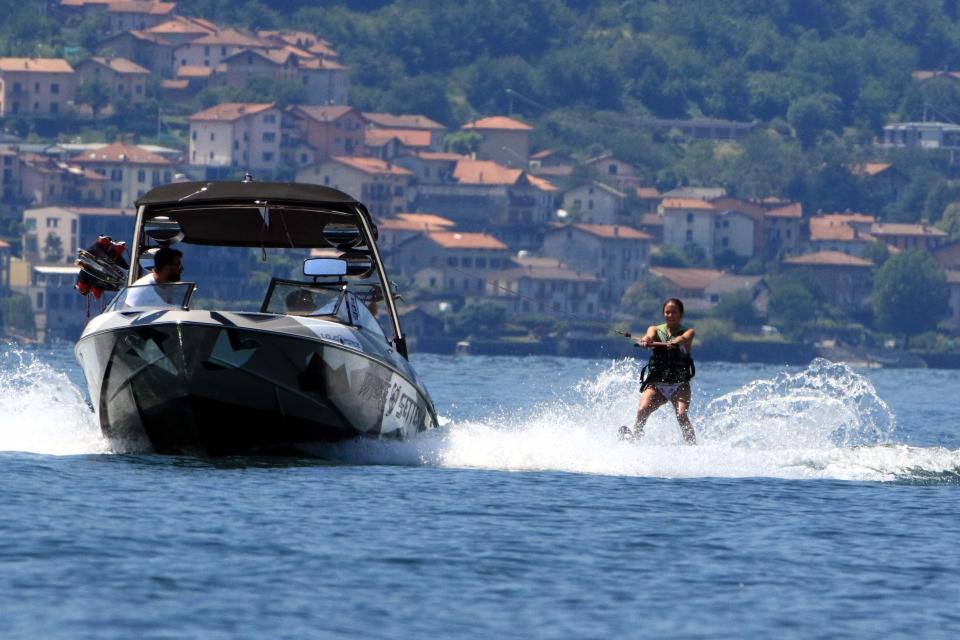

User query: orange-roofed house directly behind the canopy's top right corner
[297,156,413,217]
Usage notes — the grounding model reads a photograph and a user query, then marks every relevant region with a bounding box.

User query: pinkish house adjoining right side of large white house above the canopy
[287,105,369,162]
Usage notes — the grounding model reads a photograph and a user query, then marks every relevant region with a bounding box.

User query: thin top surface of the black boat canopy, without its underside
[136,181,359,207]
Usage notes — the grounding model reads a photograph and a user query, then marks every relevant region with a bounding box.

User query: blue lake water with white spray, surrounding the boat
[0,347,960,638]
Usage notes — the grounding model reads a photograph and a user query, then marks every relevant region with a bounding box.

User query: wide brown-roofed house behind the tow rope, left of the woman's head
[487,262,601,320]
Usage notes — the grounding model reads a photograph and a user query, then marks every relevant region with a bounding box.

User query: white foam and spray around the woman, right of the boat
[337,360,960,481]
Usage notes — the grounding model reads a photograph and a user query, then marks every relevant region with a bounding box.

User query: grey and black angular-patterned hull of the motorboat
[77,316,437,456]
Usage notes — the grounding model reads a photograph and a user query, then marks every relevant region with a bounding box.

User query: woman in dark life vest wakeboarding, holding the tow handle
[620,298,697,444]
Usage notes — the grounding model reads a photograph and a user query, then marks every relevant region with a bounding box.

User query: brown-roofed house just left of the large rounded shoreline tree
[782,251,874,312]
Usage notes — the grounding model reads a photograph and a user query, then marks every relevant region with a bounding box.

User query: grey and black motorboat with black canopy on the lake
[76,179,437,456]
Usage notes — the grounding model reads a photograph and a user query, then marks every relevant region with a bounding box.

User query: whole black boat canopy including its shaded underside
[137,182,376,248]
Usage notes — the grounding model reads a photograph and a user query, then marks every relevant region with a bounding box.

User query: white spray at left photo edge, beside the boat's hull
[0,347,110,455]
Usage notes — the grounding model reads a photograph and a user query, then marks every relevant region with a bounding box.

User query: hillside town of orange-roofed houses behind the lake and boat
[0,0,960,362]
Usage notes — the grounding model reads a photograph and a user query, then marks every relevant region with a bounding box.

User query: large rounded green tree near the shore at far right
[873,250,950,344]
